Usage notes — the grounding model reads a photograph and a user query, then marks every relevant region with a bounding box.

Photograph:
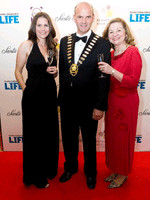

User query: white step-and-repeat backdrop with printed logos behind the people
[0,0,150,151]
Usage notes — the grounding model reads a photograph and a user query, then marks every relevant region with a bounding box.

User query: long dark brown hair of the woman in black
[28,12,57,56]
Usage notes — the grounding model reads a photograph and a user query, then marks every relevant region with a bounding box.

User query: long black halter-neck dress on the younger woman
[22,43,59,188]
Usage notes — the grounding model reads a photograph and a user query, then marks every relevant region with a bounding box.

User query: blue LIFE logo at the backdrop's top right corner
[130,11,150,22]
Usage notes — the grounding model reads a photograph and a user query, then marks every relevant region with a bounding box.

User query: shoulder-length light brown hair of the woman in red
[102,18,135,48]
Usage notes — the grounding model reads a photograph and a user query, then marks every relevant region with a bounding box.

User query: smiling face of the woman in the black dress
[36,17,50,39]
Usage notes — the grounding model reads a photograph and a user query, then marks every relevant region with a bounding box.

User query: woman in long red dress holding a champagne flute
[99,18,142,188]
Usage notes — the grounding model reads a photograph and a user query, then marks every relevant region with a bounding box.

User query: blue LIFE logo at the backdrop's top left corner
[0,13,19,24]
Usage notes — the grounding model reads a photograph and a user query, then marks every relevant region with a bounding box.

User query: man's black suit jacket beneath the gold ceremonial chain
[58,32,111,111]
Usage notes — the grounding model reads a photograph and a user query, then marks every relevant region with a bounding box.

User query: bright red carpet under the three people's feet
[0,152,150,200]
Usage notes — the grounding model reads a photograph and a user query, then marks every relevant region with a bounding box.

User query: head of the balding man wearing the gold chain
[73,3,94,35]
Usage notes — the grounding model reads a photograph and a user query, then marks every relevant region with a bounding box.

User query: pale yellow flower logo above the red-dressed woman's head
[95,5,113,26]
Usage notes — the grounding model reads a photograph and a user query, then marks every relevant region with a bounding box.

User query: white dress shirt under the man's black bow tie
[74,30,92,64]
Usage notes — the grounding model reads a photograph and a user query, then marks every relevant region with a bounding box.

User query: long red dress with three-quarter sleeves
[105,46,142,175]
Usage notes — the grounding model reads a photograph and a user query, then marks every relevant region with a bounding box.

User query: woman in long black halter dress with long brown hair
[15,12,59,188]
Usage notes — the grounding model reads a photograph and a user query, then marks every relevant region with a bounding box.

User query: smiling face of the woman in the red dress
[108,22,126,46]
